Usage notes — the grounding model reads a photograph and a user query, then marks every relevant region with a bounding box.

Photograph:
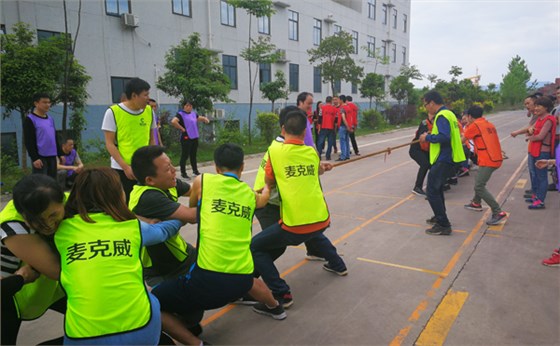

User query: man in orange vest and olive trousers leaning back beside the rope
[462,106,507,225]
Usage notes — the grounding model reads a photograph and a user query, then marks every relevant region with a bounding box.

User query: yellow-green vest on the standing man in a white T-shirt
[110,105,153,165]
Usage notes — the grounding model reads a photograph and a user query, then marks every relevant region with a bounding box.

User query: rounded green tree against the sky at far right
[500,55,531,105]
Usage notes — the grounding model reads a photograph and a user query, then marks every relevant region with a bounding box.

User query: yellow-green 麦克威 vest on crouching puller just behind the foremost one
[197,173,256,274]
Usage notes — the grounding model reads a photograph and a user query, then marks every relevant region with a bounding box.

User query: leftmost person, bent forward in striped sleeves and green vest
[0,174,66,345]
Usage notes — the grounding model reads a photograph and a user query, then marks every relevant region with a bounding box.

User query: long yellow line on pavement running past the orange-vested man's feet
[389,157,527,346]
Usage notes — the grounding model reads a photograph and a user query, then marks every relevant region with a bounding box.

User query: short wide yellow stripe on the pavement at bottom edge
[415,290,469,346]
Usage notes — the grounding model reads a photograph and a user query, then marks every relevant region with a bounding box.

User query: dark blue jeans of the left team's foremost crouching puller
[251,223,346,296]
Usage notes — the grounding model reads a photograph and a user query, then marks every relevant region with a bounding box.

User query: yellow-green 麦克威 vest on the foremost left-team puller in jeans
[268,144,329,227]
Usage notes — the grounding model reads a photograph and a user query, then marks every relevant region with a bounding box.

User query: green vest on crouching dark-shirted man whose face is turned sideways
[128,185,188,275]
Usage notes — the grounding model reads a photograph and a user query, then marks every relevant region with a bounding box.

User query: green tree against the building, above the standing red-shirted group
[307,31,364,95]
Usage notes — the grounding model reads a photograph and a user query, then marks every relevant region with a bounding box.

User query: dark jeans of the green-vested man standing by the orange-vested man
[426,162,453,227]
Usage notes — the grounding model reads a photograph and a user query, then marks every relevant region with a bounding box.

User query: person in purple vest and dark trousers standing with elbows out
[171,100,210,179]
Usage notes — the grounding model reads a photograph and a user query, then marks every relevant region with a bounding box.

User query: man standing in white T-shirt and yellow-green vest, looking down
[101,78,157,203]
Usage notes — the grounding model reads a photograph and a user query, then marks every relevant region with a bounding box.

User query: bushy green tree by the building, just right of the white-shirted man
[156,33,231,112]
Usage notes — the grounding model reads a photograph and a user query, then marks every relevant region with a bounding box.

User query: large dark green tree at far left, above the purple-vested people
[0,23,91,168]
